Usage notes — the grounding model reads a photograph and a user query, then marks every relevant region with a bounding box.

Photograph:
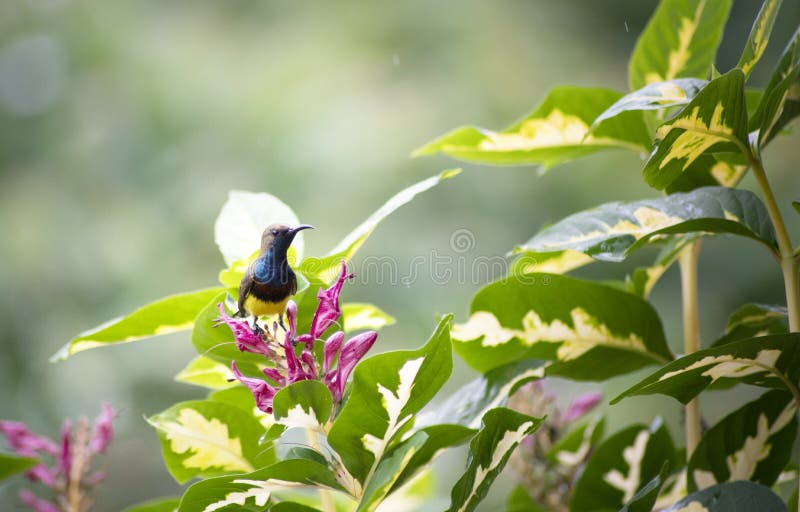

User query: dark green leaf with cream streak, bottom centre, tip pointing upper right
[448,407,544,512]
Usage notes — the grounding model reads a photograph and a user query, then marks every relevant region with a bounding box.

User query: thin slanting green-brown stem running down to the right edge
[747,154,800,332]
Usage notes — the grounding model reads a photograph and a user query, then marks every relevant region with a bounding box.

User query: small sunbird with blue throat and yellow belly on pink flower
[236,224,314,332]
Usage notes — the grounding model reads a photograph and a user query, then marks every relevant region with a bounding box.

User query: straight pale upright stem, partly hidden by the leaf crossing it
[678,240,700,461]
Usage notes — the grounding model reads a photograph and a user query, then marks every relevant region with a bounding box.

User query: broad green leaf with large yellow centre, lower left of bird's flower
[147,400,272,483]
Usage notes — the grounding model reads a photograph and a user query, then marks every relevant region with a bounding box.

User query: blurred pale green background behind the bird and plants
[0,0,800,510]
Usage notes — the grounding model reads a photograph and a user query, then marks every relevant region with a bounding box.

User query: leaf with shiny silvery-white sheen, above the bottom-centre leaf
[415,359,545,428]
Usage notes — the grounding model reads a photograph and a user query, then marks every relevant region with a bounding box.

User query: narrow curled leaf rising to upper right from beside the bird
[300,169,461,283]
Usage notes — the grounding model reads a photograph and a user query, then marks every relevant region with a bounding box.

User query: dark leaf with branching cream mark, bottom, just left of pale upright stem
[570,419,677,512]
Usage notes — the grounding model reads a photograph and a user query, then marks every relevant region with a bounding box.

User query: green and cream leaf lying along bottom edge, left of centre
[178,459,345,512]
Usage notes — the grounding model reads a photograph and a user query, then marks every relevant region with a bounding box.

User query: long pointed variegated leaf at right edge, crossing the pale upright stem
[611,333,800,404]
